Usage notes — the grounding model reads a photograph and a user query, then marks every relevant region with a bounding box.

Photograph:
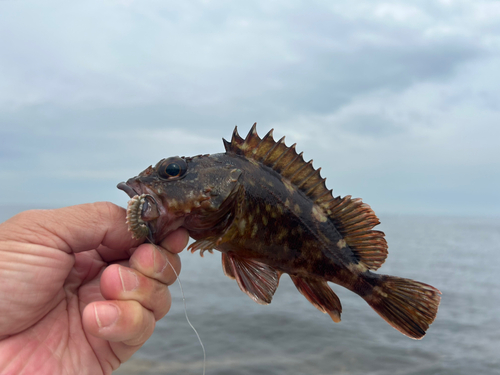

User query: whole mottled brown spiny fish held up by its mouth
[117,124,441,339]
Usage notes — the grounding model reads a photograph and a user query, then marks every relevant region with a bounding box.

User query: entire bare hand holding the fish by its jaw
[0,202,188,375]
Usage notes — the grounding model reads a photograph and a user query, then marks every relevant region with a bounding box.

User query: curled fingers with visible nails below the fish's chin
[88,229,188,361]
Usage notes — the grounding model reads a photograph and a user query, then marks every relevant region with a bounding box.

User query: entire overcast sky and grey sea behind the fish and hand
[0,0,500,374]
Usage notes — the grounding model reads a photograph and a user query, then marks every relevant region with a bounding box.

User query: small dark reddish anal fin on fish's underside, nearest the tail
[290,275,342,323]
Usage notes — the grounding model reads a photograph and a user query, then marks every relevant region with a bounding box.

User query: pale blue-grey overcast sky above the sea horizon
[0,0,500,216]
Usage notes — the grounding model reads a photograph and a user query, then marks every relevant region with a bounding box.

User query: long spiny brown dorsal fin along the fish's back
[223,123,387,270]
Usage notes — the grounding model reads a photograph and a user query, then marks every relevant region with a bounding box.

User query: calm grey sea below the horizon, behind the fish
[0,210,500,375]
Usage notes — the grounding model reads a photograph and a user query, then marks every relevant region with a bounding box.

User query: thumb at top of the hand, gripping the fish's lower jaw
[0,202,142,254]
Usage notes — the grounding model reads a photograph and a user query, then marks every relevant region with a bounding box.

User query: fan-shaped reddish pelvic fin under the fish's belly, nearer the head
[222,252,280,305]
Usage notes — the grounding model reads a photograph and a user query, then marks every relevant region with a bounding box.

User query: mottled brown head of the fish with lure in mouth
[117,154,241,243]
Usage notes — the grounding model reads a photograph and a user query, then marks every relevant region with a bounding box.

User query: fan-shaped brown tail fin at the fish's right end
[363,275,441,340]
